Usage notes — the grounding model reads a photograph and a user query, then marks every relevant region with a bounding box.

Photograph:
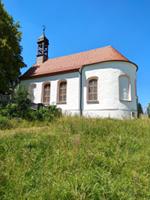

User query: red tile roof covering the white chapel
[20,46,129,79]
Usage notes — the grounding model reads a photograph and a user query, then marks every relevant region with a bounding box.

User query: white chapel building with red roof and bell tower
[20,33,138,119]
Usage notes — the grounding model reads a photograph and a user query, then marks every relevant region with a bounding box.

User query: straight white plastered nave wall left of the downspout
[21,72,80,115]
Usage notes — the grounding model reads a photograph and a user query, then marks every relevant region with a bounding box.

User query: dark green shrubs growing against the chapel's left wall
[0,86,61,121]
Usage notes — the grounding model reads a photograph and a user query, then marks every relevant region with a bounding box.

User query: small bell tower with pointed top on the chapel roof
[36,26,49,64]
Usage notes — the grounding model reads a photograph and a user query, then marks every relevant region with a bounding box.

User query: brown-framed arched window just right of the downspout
[87,78,98,102]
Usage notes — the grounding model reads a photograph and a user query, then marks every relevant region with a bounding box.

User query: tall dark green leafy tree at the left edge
[0,0,25,94]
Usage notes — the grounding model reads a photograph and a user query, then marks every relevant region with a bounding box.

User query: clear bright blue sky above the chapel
[3,0,150,107]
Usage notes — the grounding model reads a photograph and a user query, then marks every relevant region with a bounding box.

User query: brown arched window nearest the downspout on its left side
[58,81,67,104]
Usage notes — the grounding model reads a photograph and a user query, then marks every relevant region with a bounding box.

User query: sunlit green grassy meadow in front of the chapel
[0,117,150,200]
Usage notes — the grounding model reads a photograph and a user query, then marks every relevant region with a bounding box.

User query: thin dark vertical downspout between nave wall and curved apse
[79,67,83,116]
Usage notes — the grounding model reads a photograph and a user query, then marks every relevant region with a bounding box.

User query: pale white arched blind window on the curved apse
[119,75,131,101]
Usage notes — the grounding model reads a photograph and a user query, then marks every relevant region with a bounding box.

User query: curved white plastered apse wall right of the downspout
[82,61,137,119]
